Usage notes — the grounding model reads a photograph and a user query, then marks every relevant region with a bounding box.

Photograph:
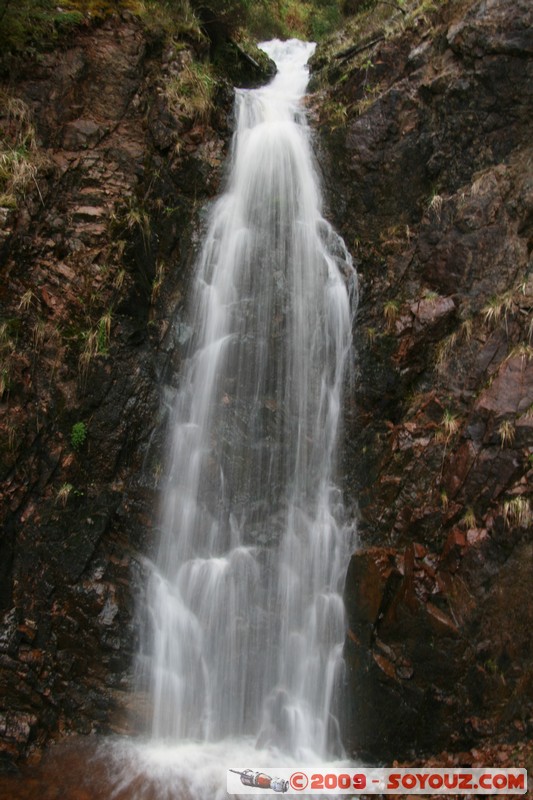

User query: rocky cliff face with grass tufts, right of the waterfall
[314,0,533,759]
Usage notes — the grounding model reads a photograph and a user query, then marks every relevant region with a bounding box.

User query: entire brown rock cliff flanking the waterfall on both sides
[0,0,533,765]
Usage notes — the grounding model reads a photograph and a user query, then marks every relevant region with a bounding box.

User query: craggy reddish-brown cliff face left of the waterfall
[0,10,237,758]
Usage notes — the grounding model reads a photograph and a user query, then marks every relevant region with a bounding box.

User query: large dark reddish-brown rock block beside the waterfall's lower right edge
[345,531,533,759]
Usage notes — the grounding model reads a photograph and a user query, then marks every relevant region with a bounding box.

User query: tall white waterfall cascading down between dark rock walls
[135,40,356,780]
